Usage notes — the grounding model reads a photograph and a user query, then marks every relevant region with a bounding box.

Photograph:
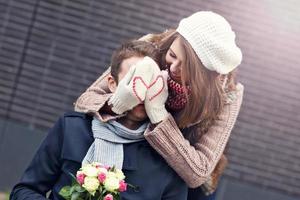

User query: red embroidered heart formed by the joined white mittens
[132,75,165,102]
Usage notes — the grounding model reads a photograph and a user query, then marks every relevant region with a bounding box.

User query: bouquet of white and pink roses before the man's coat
[59,162,127,200]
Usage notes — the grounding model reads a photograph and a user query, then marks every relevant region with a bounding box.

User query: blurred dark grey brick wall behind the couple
[0,0,300,200]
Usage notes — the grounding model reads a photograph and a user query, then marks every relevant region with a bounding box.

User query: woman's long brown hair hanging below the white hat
[158,30,224,144]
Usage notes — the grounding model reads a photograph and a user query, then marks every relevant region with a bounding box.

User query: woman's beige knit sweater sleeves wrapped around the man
[74,69,244,188]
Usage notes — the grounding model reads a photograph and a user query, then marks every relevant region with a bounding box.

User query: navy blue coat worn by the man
[10,112,187,200]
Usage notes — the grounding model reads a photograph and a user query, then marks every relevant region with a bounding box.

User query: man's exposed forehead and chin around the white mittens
[112,56,148,122]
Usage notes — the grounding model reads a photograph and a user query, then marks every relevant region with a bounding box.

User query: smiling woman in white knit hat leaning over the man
[75,11,243,200]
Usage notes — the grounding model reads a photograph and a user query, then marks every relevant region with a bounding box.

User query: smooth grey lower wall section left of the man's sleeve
[0,120,46,190]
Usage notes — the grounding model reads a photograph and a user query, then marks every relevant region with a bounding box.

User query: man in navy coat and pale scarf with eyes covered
[10,41,187,200]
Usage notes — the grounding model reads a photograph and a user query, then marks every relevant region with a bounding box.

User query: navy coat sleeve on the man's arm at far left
[10,118,63,200]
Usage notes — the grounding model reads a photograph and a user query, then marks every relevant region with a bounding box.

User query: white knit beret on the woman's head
[176,11,242,74]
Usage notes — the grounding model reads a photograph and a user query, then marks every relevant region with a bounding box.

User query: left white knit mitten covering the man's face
[108,56,158,114]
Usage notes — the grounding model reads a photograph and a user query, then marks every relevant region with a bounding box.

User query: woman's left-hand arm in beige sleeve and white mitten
[75,56,167,122]
